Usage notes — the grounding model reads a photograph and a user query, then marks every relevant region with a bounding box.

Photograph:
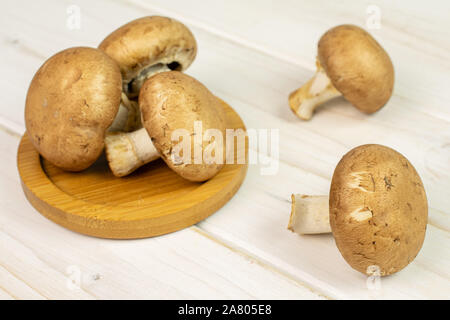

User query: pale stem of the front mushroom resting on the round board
[105,128,159,177]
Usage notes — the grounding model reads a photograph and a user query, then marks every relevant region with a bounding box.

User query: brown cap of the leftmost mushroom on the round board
[25,47,122,171]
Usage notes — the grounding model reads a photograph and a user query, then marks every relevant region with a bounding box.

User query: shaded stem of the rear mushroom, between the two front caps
[108,92,142,132]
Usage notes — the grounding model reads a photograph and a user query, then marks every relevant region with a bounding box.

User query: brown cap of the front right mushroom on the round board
[139,71,226,181]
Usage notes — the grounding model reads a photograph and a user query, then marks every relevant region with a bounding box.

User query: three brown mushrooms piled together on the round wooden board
[25,16,227,181]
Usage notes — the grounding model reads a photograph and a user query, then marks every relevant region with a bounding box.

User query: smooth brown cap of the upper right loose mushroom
[318,25,394,113]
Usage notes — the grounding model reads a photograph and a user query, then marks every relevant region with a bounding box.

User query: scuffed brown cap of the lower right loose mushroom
[330,144,428,276]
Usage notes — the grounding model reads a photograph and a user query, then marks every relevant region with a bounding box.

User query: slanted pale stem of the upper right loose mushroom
[289,61,342,120]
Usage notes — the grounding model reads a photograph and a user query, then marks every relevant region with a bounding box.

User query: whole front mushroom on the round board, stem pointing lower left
[105,71,226,181]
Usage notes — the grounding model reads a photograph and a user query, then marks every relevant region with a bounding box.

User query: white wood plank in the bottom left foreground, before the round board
[0,130,324,299]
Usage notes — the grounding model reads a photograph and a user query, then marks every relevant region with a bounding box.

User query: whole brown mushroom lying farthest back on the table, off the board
[289,25,394,120]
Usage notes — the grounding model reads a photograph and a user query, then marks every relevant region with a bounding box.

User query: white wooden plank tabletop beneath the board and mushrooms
[0,0,450,299]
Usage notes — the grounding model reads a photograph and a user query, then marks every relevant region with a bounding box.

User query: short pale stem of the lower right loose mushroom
[288,194,331,235]
